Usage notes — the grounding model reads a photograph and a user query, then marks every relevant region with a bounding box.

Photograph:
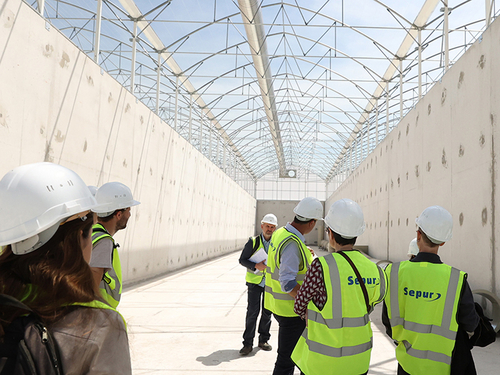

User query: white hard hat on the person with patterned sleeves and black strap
[325,199,365,239]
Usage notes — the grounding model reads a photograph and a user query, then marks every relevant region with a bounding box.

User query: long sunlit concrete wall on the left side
[0,0,256,283]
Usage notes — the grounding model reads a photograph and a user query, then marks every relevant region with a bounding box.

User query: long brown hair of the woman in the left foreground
[0,214,100,331]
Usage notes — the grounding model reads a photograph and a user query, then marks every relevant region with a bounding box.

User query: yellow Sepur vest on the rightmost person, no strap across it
[386,261,467,374]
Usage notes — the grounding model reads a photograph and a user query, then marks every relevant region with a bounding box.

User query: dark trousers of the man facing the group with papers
[243,283,271,346]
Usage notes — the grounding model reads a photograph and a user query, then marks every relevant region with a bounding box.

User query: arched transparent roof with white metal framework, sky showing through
[37,0,496,181]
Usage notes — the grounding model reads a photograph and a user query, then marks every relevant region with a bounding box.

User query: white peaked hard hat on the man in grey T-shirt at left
[94,182,141,217]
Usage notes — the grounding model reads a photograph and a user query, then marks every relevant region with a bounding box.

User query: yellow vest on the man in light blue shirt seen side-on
[264,227,313,317]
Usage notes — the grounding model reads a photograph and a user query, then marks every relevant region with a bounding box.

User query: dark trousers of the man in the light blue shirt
[273,314,306,375]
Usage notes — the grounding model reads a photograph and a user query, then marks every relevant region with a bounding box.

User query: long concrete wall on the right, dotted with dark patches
[326,21,500,294]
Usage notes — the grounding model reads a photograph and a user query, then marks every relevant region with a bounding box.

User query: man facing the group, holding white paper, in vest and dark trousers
[240,214,278,355]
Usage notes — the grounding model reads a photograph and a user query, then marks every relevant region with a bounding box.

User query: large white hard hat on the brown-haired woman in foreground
[0,163,103,255]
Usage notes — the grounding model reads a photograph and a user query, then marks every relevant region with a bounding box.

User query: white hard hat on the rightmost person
[415,206,453,245]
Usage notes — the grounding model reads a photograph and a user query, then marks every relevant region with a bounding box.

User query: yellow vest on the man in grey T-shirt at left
[92,224,122,308]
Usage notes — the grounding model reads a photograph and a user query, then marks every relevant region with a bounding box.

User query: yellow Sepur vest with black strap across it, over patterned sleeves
[292,251,386,375]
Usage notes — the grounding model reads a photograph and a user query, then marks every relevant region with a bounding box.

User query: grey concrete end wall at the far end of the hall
[255,200,324,246]
